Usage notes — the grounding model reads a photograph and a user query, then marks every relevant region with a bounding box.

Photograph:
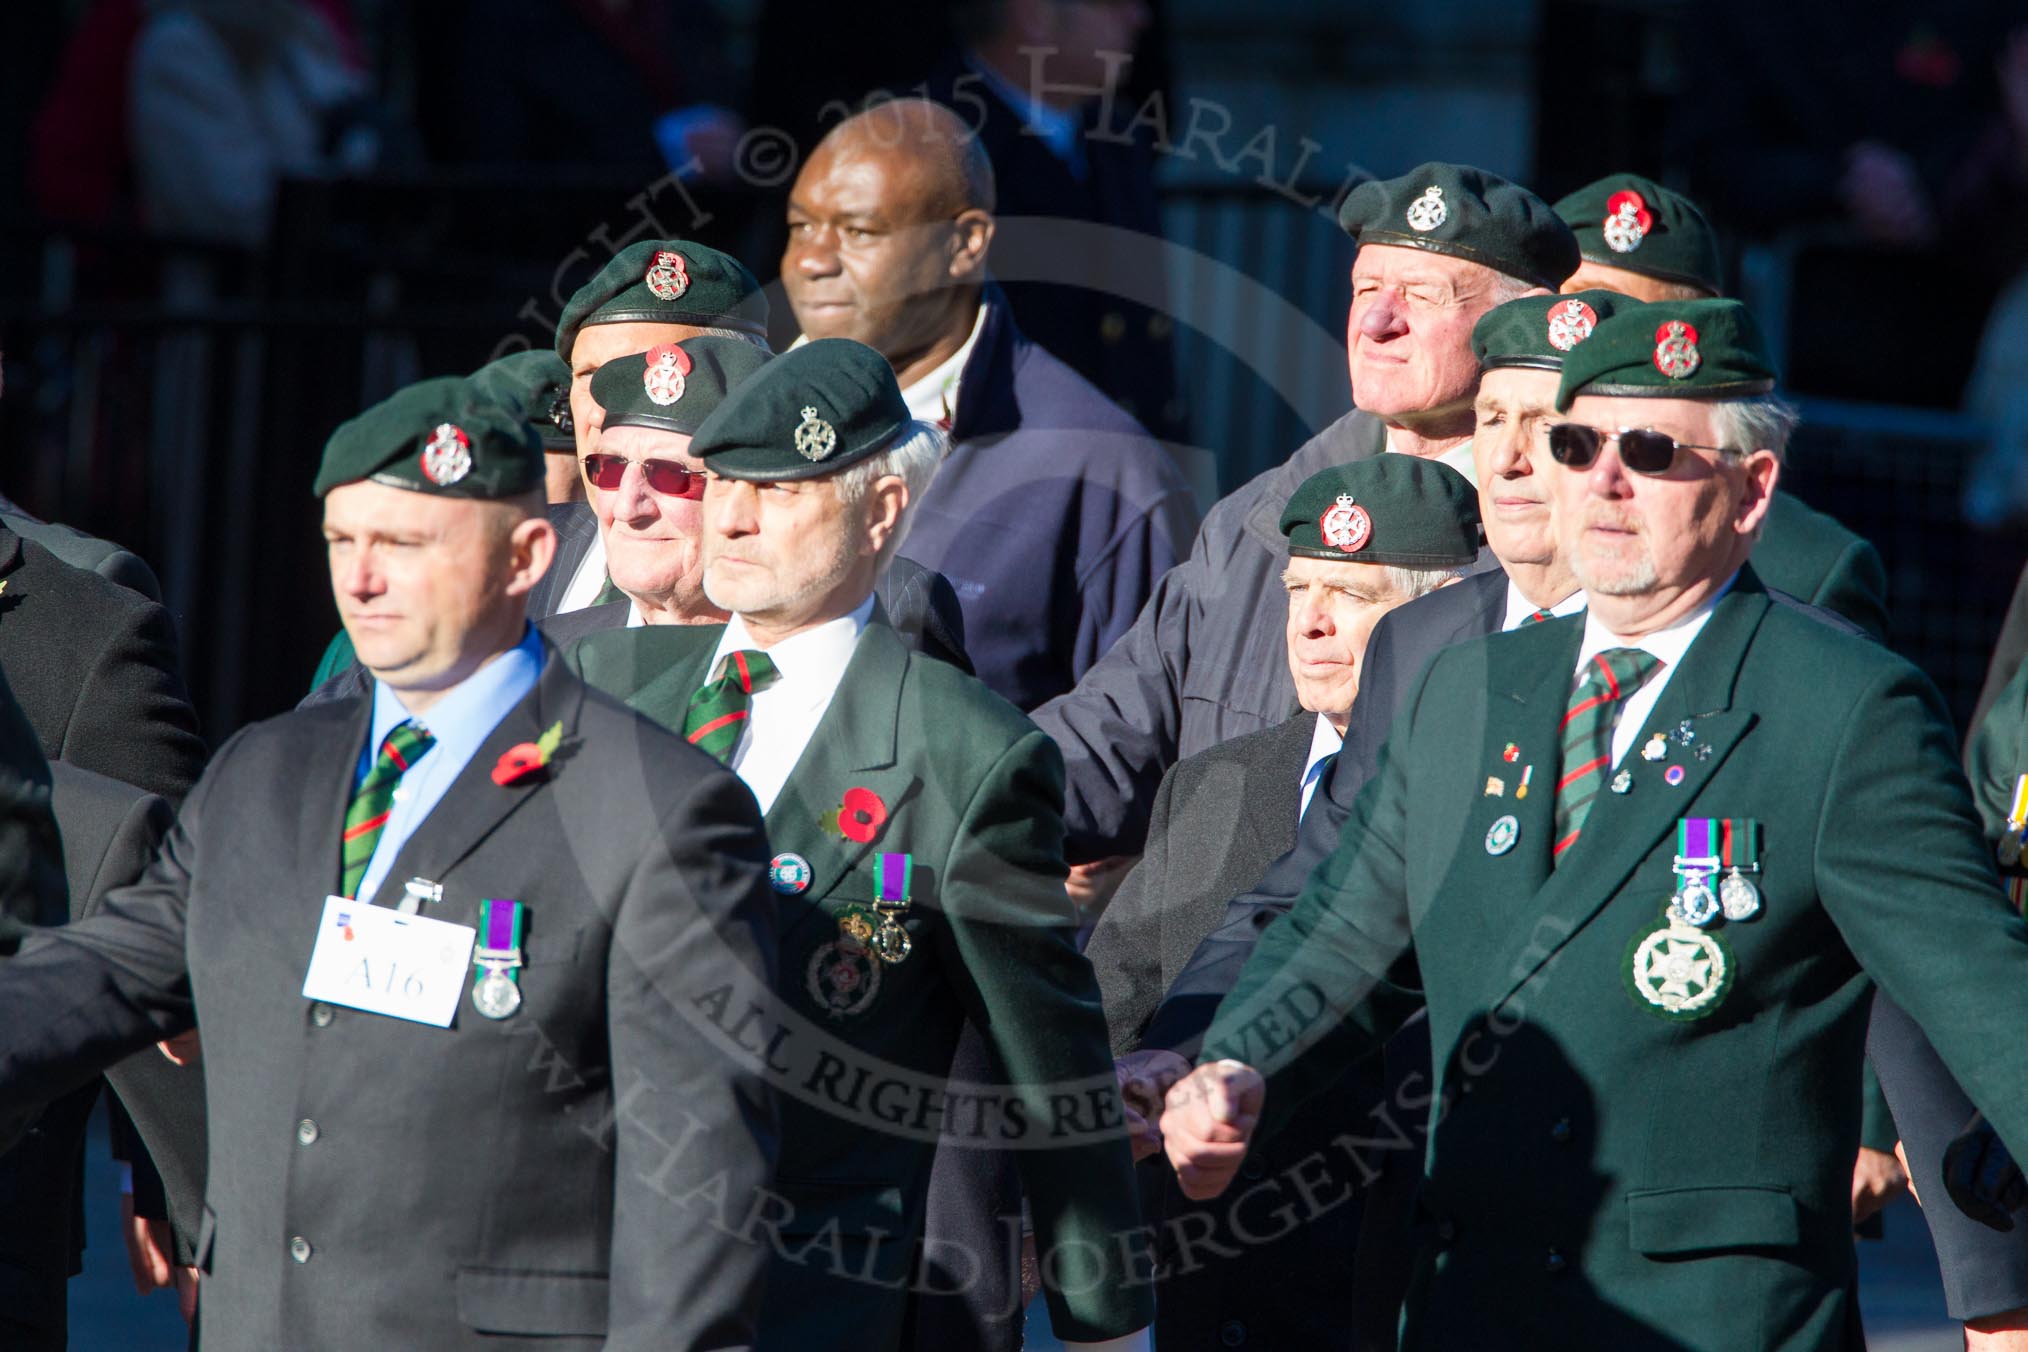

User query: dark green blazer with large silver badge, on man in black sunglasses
[1205,568,2028,1352]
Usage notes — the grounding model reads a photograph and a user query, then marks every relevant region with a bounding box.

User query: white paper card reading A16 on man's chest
[302,896,479,1028]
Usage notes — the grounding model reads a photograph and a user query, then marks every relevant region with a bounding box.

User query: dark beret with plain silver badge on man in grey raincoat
[1338,162,1578,292]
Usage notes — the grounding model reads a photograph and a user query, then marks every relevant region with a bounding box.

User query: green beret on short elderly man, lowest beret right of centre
[1282,452,1478,568]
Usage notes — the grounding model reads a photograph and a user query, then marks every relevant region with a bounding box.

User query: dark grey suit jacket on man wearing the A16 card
[0,655,777,1352]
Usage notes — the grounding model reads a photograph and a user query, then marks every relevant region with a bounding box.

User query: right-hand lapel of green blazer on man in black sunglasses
[1501,568,1768,1001]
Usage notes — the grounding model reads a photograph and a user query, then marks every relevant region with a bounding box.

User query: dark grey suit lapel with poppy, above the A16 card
[375,643,602,906]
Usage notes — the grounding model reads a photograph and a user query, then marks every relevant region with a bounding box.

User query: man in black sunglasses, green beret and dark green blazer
[1162,300,2028,1352]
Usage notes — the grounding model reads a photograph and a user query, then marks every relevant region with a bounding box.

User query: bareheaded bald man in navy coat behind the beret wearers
[781,99,1197,709]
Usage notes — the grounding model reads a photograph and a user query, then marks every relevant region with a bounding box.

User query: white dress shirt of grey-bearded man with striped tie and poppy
[706,596,874,813]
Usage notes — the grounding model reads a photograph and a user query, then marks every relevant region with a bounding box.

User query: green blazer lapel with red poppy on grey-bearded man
[767,628,917,941]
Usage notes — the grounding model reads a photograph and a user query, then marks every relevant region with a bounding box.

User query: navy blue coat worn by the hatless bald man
[900,288,1197,709]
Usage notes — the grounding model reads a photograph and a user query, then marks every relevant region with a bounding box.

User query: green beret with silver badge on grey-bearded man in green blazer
[690,339,909,482]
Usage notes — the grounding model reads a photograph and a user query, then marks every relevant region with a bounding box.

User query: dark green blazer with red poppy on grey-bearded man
[574,610,1152,1352]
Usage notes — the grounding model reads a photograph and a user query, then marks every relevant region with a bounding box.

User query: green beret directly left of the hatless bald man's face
[556,239,767,361]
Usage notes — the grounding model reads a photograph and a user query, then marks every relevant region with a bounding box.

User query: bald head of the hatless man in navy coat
[781,99,994,387]
